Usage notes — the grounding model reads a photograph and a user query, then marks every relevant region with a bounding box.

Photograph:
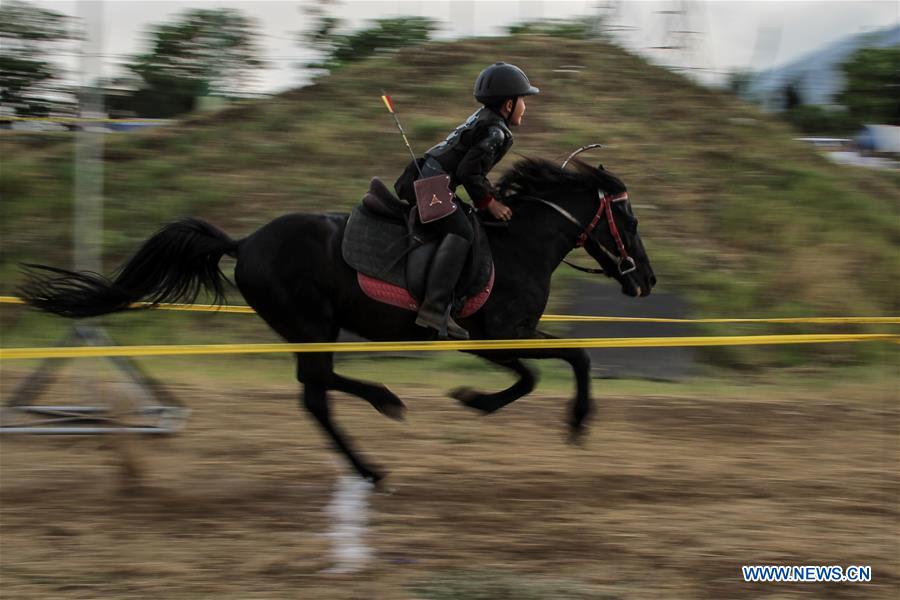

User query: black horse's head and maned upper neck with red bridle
[500,159,656,296]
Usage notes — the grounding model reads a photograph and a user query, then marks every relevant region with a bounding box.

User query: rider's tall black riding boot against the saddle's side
[416,233,472,340]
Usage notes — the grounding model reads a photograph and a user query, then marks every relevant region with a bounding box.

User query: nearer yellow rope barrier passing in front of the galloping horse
[0,333,900,360]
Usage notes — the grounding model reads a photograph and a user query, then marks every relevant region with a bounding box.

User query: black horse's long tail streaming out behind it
[18,219,238,318]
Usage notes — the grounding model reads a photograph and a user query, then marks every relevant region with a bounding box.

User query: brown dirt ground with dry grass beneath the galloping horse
[0,372,900,600]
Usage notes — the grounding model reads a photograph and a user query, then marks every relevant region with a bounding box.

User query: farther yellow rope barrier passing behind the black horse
[0,296,900,325]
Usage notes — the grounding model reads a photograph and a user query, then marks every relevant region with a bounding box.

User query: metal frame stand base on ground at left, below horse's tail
[0,325,191,435]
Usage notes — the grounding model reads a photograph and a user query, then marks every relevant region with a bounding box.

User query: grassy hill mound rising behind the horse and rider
[0,36,900,365]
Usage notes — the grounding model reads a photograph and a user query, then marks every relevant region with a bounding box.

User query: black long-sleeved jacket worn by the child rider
[394,106,513,208]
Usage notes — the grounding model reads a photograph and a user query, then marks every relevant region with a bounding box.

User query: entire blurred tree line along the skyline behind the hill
[0,0,900,126]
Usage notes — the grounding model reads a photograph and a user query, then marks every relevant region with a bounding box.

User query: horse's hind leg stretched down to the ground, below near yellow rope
[297,352,384,483]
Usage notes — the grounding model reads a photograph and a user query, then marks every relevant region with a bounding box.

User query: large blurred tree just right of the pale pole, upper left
[115,9,264,117]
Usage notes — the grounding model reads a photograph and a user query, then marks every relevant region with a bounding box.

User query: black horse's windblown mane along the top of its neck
[497,158,625,196]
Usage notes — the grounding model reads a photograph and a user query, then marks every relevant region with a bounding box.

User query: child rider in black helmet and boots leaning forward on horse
[394,62,540,340]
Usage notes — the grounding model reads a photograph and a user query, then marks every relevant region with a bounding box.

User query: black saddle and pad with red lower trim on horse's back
[341,177,494,318]
